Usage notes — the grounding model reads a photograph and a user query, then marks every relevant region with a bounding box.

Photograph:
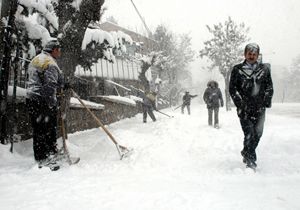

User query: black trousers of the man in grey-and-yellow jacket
[26,99,57,161]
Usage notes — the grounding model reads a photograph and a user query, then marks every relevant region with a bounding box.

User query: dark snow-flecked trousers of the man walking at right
[240,110,265,161]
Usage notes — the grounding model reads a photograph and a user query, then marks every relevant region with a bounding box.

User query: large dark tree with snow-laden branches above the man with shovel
[0,0,132,143]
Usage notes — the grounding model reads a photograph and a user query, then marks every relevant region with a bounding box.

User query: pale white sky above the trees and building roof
[104,0,300,70]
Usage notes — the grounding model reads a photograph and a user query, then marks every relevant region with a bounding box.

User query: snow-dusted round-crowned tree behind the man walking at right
[199,17,249,110]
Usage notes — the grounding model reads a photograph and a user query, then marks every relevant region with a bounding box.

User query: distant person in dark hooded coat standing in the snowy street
[203,80,224,128]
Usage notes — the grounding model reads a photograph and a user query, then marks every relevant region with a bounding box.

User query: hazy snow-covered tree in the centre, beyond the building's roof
[154,25,194,105]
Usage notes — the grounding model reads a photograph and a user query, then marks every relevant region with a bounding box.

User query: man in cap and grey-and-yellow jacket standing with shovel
[26,40,63,170]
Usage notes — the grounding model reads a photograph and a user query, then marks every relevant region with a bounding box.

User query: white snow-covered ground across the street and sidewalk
[0,103,300,210]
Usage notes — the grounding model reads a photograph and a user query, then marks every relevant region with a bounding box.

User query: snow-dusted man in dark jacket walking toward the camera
[229,43,273,168]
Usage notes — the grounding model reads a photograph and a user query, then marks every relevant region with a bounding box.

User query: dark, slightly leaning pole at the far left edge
[0,0,18,144]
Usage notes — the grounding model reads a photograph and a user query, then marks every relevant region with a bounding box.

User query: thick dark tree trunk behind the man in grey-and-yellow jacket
[57,0,104,135]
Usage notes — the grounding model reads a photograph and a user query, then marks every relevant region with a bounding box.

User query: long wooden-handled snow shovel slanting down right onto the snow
[71,89,133,160]
